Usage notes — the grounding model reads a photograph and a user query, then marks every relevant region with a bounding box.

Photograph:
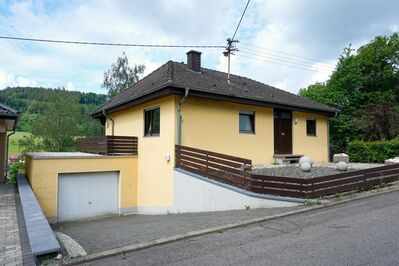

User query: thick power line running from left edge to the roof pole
[0,36,226,49]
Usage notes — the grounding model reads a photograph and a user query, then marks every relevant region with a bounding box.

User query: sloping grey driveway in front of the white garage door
[52,206,303,254]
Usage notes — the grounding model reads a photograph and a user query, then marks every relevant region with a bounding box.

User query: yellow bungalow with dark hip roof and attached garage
[26,51,338,221]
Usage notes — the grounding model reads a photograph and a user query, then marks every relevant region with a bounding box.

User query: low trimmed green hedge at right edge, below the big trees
[347,138,399,163]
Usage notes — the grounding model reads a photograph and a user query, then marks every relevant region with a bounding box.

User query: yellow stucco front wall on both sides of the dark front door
[182,97,328,164]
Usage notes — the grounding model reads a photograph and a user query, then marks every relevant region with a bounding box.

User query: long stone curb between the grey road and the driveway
[62,184,399,265]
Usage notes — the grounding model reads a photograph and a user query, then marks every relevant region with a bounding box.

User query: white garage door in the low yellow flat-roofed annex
[57,172,119,222]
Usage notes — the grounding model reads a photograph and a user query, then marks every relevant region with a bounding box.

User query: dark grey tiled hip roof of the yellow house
[93,61,339,115]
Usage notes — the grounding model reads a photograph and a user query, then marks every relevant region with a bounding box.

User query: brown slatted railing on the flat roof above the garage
[76,136,138,155]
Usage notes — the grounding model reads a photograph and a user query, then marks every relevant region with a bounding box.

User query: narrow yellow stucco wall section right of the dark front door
[292,112,328,162]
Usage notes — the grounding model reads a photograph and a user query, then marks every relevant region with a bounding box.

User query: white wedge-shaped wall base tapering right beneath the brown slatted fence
[171,170,303,212]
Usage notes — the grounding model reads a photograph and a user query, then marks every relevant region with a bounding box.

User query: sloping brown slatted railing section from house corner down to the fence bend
[175,145,252,188]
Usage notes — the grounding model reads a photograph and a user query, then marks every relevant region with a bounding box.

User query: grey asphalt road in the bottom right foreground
[88,192,399,265]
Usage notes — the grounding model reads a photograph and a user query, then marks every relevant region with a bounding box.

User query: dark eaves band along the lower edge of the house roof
[91,83,339,118]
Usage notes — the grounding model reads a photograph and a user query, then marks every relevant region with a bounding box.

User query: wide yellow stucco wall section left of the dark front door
[182,97,274,164]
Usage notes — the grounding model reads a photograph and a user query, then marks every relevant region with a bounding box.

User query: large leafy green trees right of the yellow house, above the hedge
[299,33,399,153]
